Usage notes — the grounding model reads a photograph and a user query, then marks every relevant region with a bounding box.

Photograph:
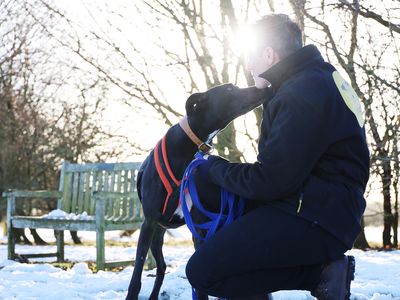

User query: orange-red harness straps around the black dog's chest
[154,136,182,218]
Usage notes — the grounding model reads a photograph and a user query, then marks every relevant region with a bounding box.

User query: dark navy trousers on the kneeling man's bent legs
[186,205,347,297]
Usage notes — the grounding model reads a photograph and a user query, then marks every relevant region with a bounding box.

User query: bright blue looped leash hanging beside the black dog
[180,152,244,300]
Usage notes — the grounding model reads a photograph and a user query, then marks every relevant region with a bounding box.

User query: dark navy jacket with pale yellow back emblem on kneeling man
[207,45,369,248]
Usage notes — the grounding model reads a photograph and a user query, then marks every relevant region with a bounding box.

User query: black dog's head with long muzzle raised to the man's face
[186,84,267,141]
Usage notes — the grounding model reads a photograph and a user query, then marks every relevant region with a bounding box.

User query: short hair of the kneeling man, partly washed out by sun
[252,14,303,59]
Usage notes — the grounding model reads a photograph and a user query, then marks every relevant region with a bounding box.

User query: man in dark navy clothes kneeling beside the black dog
[186,14,369,300]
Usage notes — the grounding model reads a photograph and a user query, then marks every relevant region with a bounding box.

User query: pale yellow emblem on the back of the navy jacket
[332,71,364,127]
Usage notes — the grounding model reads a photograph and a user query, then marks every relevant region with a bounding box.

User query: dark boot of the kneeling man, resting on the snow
[311,256,356,300]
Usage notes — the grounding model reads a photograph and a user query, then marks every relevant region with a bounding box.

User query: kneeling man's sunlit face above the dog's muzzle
[247,46,279,89]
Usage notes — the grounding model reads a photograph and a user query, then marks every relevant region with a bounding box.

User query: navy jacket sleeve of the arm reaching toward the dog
[208,85,329,201]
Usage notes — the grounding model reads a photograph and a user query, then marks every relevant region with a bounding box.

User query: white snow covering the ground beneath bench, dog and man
[0,229,400,300]
